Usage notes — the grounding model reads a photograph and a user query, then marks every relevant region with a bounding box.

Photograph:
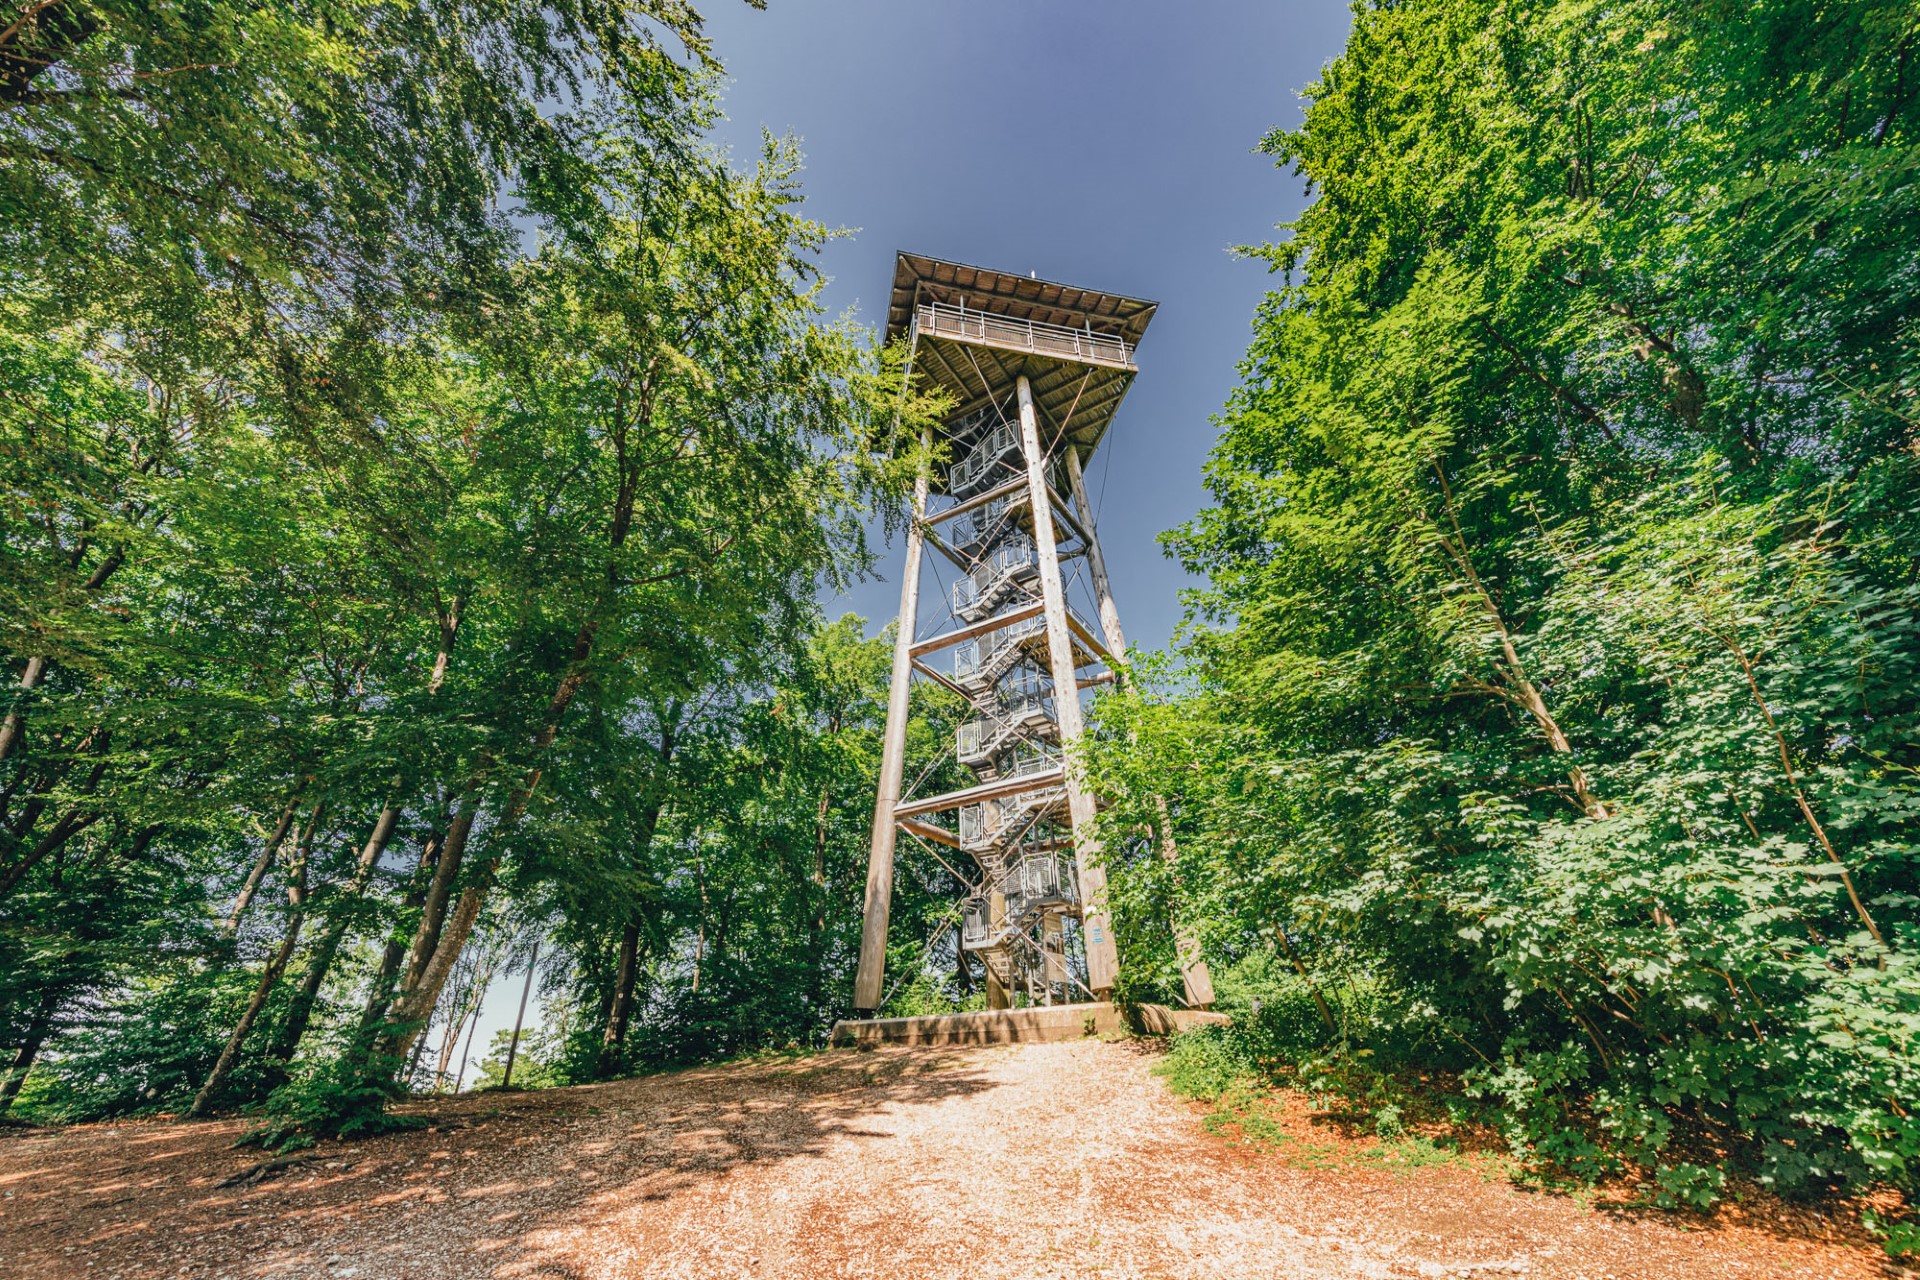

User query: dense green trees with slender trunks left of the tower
[0,2,967,1130]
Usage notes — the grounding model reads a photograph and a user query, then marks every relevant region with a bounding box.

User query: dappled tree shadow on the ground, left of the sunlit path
[0,1050,995,1280]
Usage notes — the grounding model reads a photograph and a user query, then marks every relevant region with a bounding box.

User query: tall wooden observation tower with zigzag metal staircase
[854,253,1213,1013]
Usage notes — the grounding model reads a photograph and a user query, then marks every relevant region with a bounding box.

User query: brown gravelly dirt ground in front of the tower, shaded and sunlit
[0,1042,1905,1280]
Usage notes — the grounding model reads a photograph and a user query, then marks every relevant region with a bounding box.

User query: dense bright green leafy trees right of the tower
[1092,0,1920,1203]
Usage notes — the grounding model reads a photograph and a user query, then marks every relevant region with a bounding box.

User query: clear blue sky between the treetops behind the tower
[703,0,1348,647]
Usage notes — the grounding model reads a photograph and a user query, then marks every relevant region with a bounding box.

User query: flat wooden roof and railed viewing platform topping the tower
[887,253,1158,466]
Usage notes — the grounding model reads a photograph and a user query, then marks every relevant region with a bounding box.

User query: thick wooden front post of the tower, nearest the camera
[1014,374,1119,1000]
